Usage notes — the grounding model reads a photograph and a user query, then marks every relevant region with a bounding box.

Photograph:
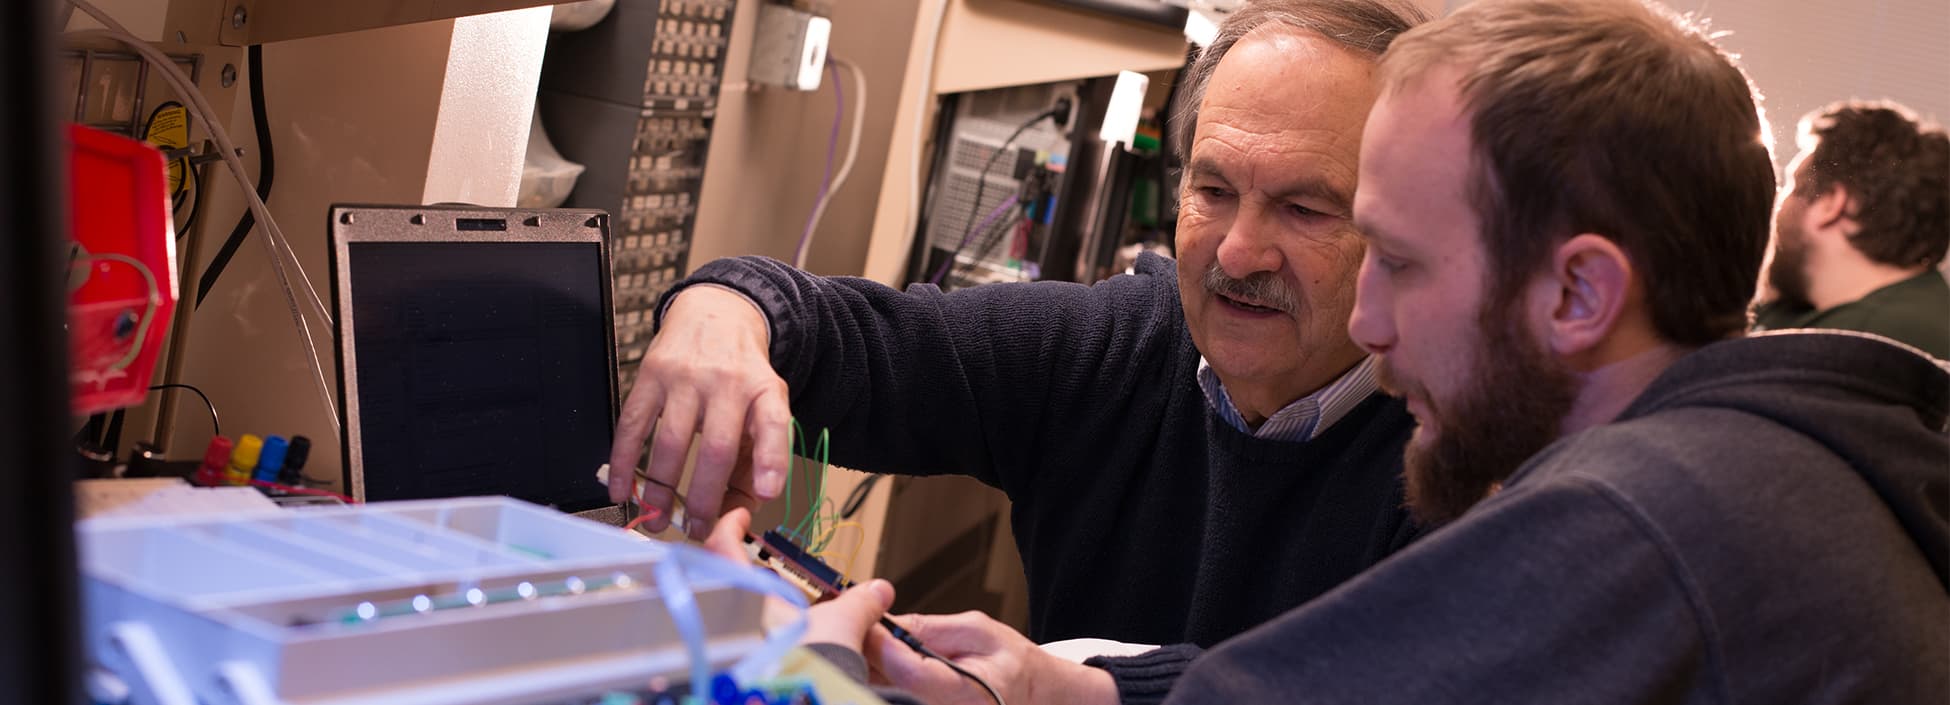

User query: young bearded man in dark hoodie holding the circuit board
[783,0,1950,705]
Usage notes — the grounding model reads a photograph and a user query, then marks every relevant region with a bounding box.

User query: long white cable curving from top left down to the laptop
[68,0,341,434]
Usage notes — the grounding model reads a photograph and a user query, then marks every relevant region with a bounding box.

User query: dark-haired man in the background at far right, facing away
[1755,101,1950,358]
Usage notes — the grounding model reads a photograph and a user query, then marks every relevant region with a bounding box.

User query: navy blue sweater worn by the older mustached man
[667,257,1416,699]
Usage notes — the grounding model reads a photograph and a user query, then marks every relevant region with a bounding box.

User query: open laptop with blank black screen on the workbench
[330,204,618,512]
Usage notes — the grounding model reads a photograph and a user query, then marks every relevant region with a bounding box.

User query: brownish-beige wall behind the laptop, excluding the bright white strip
[170,21,452,483]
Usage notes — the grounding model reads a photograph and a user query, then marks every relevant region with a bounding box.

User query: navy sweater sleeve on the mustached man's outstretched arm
[659,257,1180,497]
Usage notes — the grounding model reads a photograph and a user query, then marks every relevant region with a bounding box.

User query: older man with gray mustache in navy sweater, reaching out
[612,0,1425,697]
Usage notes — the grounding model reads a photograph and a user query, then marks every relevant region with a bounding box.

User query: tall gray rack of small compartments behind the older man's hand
[536,0,737,390]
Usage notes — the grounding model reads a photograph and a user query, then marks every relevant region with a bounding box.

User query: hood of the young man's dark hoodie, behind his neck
[1619,331,1950,590]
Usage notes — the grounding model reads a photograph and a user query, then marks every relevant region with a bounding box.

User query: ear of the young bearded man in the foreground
[1544,234,1636,358]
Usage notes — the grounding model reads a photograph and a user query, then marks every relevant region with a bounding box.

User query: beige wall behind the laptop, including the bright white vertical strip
[155,10,548,483]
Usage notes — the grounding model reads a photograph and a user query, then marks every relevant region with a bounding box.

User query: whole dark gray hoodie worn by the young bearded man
[1170,333,1950,705]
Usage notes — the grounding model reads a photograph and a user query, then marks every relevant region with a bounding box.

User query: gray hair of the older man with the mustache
[1170,0,1429,160]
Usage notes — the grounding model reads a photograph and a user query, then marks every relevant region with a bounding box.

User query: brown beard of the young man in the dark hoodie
[1379,299,1578,528]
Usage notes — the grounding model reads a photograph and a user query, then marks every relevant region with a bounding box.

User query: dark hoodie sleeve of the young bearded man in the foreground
[1168,475,1726,703]
